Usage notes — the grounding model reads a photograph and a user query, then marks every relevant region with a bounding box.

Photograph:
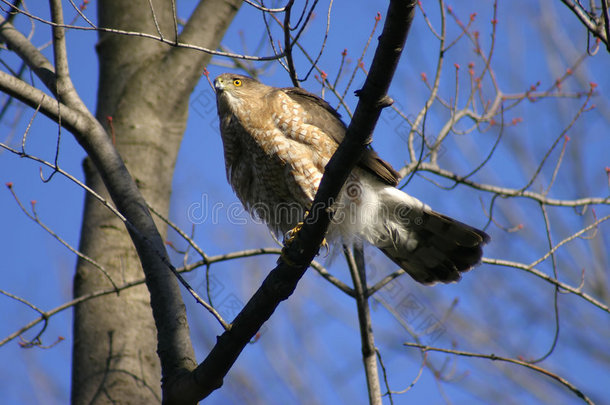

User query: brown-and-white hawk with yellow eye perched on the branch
[214,73,490,284]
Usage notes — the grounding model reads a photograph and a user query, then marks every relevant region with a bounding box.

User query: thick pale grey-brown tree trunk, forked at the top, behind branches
[72,0,235,404]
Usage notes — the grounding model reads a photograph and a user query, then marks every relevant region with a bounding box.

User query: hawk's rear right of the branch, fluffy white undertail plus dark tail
[329,170,489,284]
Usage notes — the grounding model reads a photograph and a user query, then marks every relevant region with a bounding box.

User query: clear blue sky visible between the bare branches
[0,1,610,404]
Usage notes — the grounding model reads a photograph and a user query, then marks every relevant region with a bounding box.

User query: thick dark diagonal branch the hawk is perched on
[163,0,416,404]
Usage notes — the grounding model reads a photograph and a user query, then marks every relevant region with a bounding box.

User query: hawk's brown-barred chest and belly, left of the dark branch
[219,79,338,232]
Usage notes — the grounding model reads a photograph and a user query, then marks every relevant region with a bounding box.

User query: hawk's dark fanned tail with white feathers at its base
[342,178,490,284]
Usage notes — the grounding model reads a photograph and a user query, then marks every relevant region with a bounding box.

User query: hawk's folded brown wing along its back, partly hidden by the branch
[281,87,399,186]
